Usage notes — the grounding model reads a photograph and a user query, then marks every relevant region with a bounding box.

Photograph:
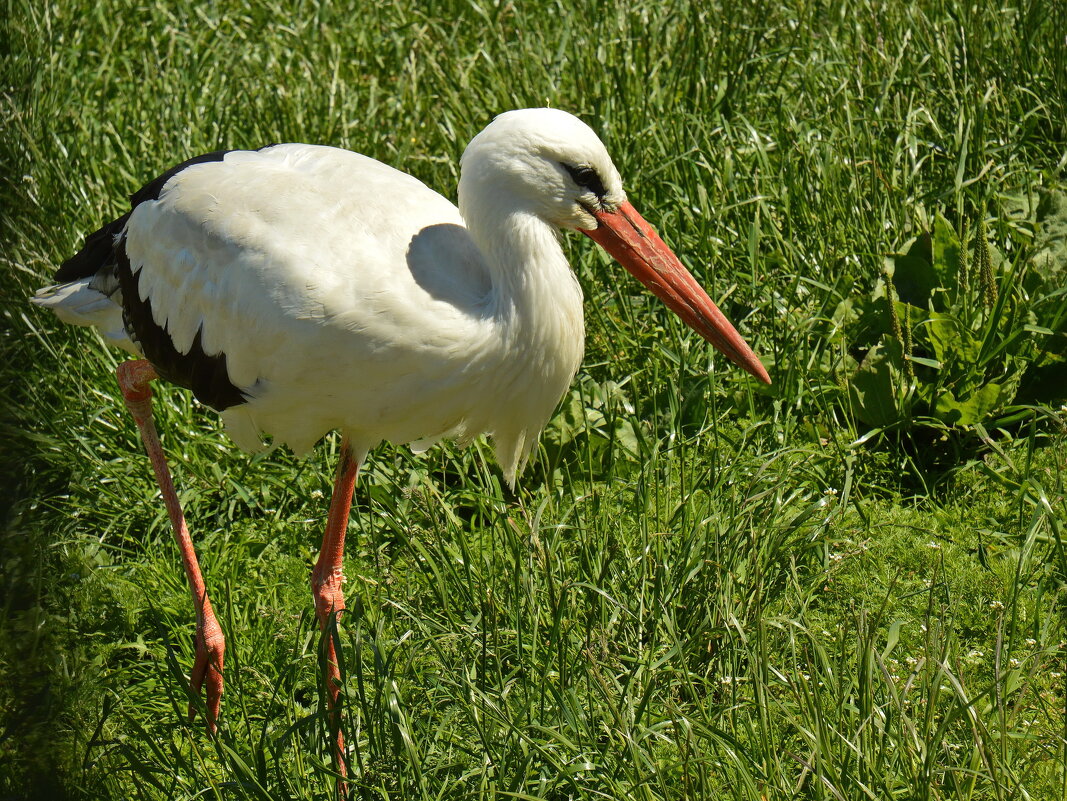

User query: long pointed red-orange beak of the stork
[580,201,770,384]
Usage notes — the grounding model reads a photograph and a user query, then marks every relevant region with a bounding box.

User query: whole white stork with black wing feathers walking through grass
[33,109,770,785]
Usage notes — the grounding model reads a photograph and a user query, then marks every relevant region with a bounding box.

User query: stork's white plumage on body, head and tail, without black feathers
[35,109,762,482]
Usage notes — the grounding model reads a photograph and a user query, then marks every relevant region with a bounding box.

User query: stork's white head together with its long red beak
[460,109,770,384]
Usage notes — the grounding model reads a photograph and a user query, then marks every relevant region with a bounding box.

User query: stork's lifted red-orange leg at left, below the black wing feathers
[117,361,226,734]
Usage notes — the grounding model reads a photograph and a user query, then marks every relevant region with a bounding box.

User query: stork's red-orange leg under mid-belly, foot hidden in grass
[312,437,362,797]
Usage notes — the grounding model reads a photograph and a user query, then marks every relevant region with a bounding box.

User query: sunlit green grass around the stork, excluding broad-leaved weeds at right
[0,0,1067,801]
